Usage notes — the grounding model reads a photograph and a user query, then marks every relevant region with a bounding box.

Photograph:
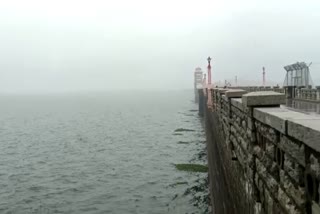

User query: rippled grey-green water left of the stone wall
[0,91,207,214]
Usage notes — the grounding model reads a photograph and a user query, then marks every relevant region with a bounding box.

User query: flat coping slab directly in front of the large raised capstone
[253,107,320,134]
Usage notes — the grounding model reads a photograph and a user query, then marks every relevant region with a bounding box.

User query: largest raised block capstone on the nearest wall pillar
[242,91,286,107]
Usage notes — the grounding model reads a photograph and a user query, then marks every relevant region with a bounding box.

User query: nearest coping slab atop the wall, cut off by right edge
[288,117,320,152]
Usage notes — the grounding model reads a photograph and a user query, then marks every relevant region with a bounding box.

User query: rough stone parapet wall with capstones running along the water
[199,88,320,214]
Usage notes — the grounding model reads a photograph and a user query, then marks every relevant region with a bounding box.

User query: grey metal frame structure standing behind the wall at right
[283,62,313,98]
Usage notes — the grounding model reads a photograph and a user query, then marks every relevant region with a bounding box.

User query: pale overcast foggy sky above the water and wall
[0,0,320,93]
